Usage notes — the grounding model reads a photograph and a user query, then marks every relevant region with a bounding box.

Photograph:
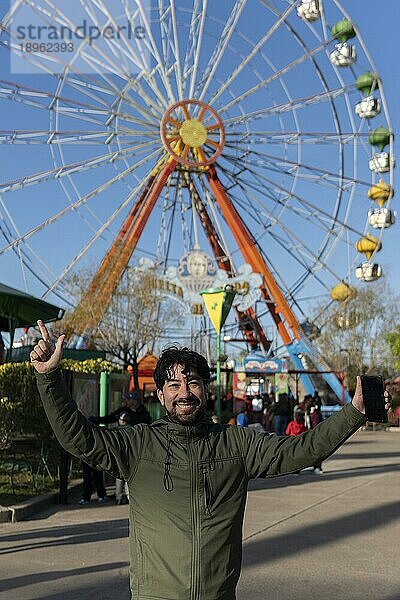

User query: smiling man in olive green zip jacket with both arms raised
[31,321,389,600]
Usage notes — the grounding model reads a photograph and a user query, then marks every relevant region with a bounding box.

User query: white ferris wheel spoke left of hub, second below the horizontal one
[0,149,162,255]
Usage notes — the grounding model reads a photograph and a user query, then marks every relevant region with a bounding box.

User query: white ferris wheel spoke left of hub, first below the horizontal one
[0,145,159,193]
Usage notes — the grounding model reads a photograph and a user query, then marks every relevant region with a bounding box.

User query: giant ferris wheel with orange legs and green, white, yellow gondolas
[0,0,395,404]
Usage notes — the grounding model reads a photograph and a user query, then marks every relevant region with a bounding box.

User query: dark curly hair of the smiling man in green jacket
[153,346,210,390]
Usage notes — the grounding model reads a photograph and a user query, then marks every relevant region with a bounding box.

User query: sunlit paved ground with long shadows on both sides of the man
[0,431,400,600]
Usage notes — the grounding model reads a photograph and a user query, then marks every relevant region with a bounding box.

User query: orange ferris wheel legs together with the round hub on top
[72,99,300,350]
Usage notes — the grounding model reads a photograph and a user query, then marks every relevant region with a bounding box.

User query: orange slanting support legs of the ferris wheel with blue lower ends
[74,144,350,402]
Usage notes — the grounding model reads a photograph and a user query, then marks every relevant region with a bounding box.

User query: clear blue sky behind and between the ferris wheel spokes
[0,0,400,346]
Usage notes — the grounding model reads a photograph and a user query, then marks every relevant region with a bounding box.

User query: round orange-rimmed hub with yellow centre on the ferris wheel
[160,99,225,168]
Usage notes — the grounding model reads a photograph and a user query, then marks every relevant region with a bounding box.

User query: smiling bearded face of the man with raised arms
[157,365,207,425]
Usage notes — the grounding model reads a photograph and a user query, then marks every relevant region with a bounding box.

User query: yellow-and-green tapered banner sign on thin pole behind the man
[200,286,236,421]
